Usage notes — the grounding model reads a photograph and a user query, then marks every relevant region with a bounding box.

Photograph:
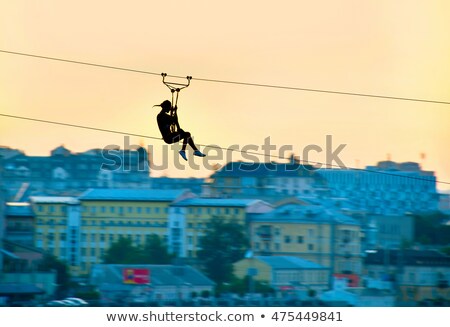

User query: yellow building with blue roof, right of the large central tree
[249,202,362,283]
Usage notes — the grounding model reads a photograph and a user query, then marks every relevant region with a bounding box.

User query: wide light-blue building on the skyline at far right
[318,161,439,216]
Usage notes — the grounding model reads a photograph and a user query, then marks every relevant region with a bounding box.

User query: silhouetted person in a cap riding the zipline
[156,100,206,160]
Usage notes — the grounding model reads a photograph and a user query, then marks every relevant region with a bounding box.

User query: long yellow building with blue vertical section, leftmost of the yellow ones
[31,189,194,276]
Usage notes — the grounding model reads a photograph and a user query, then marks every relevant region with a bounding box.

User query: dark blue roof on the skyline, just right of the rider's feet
[214,162,316,177]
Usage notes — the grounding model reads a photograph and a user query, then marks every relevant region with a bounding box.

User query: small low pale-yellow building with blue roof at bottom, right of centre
[233,256,330,299]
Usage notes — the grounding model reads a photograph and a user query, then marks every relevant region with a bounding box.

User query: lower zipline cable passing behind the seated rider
[0,113,450,185]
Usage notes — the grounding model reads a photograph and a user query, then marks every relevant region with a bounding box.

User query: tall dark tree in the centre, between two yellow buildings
[198,217,248,284]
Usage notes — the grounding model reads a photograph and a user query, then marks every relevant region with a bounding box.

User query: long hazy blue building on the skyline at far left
[0,146,151,201]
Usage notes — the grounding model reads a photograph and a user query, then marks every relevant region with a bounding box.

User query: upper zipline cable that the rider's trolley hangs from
[0,49,450,105]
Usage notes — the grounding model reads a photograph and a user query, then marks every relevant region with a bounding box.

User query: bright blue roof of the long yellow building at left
[79,189,186,202]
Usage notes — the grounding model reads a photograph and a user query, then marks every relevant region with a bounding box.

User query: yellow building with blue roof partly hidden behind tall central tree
[169,198,272,258]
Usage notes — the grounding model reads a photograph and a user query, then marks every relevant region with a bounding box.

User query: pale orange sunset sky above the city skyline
[0,0,450,189]
